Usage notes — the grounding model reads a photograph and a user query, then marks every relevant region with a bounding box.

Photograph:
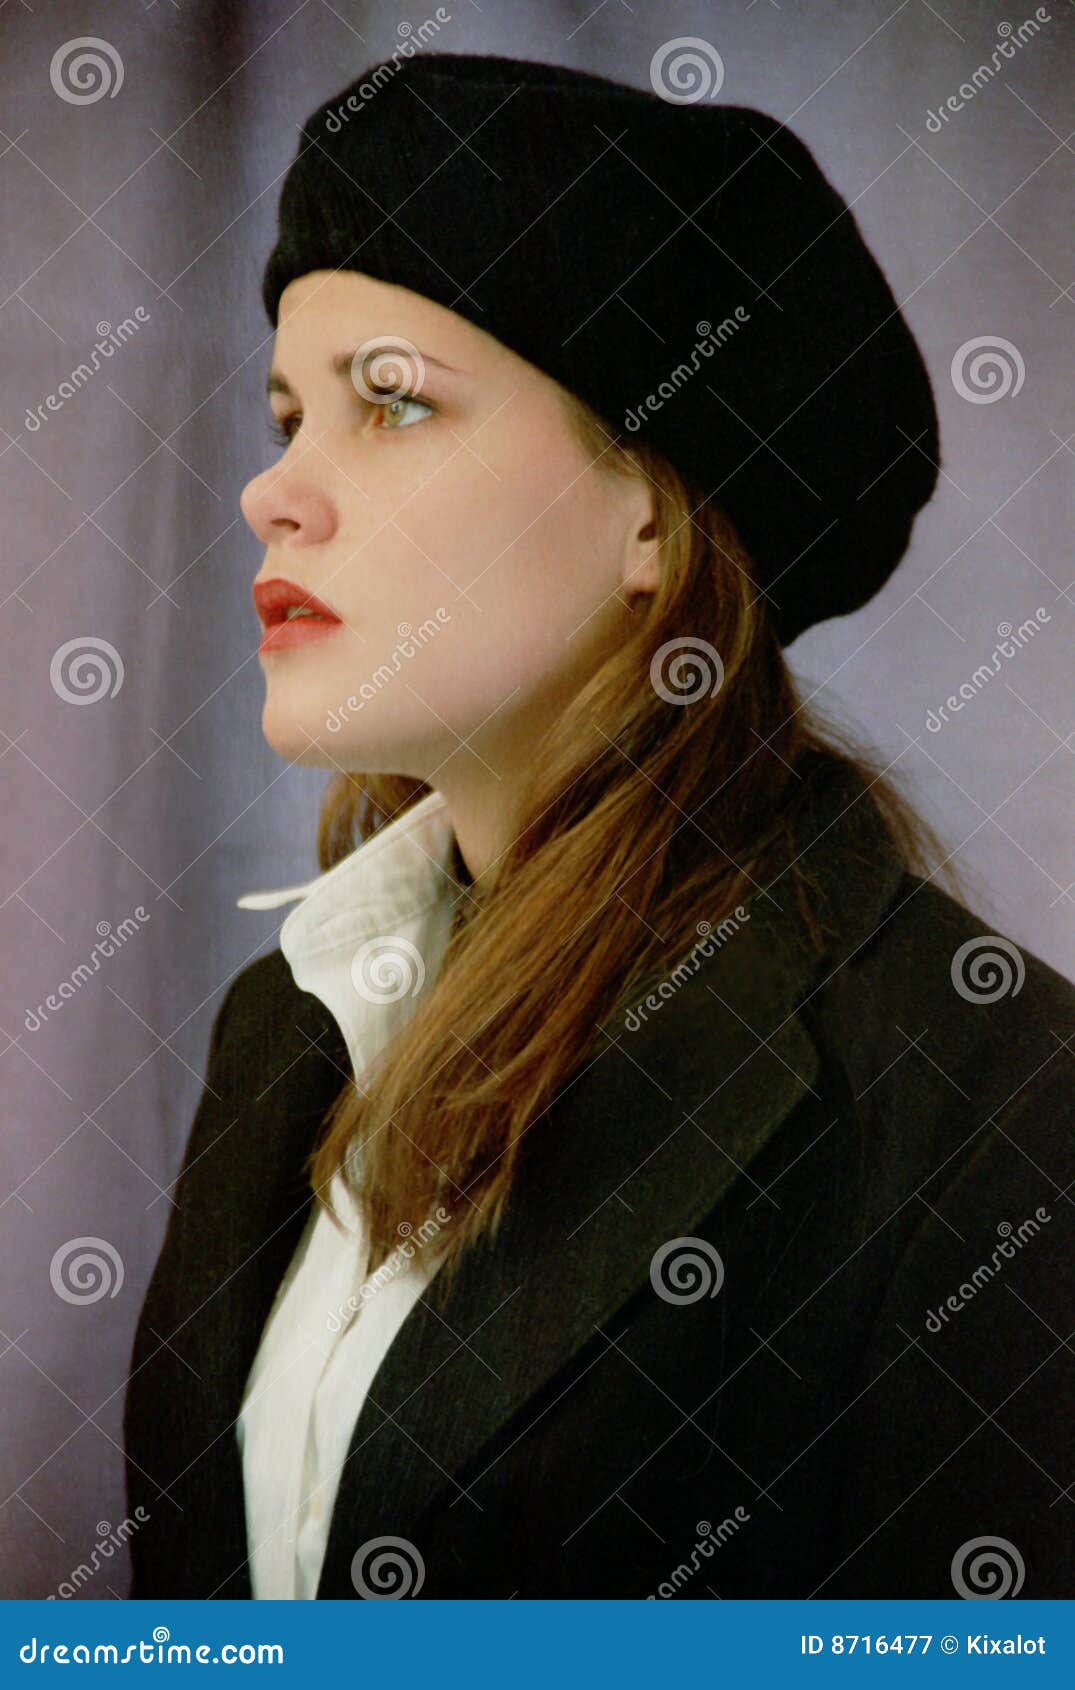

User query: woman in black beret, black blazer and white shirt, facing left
[125,54,1075,1599]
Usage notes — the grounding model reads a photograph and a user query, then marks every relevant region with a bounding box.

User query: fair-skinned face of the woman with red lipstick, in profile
[242,270,656,786]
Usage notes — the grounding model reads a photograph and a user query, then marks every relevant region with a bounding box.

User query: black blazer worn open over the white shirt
[125,760,1075,1599]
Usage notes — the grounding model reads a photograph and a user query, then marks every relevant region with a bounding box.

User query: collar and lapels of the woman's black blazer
[206,761,904,1597]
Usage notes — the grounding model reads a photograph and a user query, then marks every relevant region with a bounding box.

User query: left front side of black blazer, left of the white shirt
[157,973,350,1597]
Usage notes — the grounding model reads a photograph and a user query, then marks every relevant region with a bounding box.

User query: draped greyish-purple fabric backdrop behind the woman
[0,0,1075,1599]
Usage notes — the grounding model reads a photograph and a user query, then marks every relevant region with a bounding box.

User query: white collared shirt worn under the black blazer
[235,791,460,1597]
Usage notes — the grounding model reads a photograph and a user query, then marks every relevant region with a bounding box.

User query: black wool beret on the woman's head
[262,49,940,644]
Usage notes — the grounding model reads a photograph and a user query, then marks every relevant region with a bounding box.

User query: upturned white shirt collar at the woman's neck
[237,791,463,1077]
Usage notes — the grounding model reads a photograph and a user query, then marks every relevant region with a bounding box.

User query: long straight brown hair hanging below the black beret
[308,392,953,1289]
